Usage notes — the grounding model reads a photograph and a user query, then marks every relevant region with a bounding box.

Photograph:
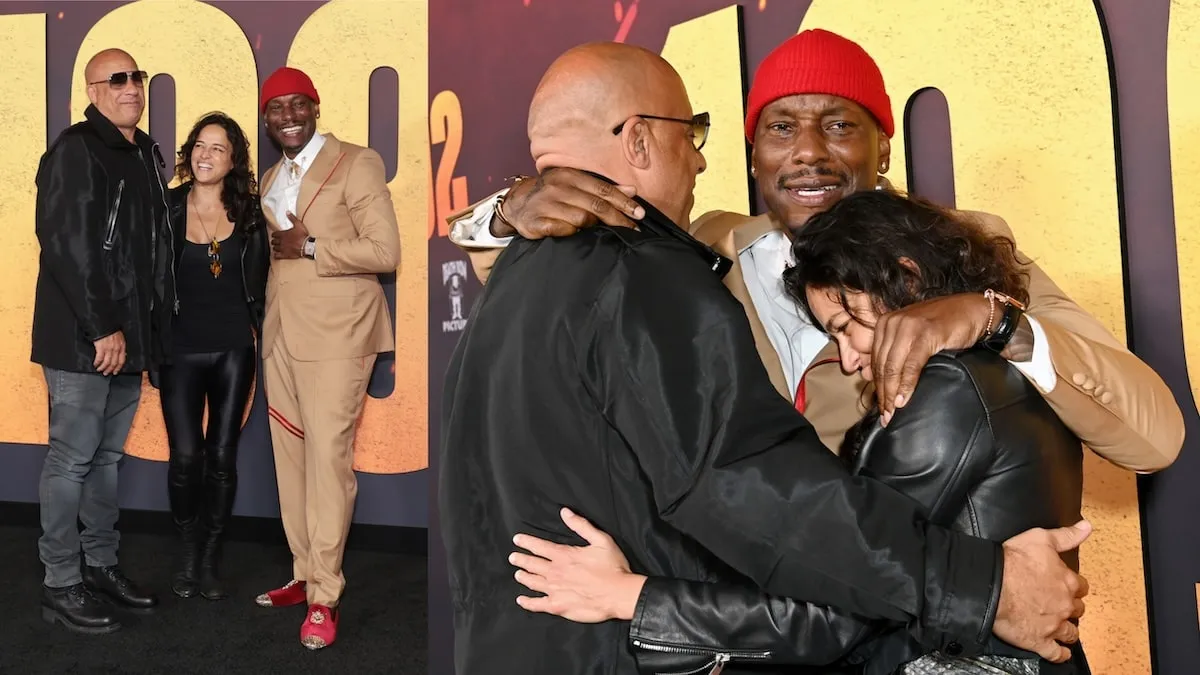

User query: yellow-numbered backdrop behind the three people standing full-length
[0,0,429,528]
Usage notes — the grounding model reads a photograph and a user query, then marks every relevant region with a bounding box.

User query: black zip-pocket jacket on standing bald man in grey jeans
[31,106,174,372]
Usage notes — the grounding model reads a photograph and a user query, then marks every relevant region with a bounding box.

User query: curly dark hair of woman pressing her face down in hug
[784,190,1028,329]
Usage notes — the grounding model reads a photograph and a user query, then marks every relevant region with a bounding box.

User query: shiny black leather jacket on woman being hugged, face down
[630,350,1087,675]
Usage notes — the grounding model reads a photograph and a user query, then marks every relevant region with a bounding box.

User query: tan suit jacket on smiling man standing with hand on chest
[262,133,400,362]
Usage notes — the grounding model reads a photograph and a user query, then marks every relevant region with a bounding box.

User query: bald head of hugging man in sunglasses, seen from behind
[528,42,704,221]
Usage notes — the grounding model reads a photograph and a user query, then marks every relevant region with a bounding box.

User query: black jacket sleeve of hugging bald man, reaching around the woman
[574,240,1002,655]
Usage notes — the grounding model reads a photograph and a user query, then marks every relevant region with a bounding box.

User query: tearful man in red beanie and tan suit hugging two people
[450,30,1183,472]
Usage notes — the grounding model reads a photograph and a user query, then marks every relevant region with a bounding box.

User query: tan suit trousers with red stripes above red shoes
[263,331,376,607]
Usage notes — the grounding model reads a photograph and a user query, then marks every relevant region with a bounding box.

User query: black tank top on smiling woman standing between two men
[172,232,254,353]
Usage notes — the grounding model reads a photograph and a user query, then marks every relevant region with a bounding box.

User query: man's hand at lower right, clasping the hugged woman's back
[992,520,1092,663]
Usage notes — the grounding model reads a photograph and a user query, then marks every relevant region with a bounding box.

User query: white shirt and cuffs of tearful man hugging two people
[450,190,1058,395]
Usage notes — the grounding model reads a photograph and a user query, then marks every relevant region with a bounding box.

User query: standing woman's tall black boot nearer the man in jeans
[167,448,204,598]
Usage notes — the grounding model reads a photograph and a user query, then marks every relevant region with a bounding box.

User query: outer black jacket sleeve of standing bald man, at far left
[35,133,121,341]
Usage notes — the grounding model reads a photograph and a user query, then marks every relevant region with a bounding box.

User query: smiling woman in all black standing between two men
[161,113,269,601]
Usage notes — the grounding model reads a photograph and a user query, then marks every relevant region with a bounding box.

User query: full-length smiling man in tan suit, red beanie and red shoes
[257,67,400,649]
